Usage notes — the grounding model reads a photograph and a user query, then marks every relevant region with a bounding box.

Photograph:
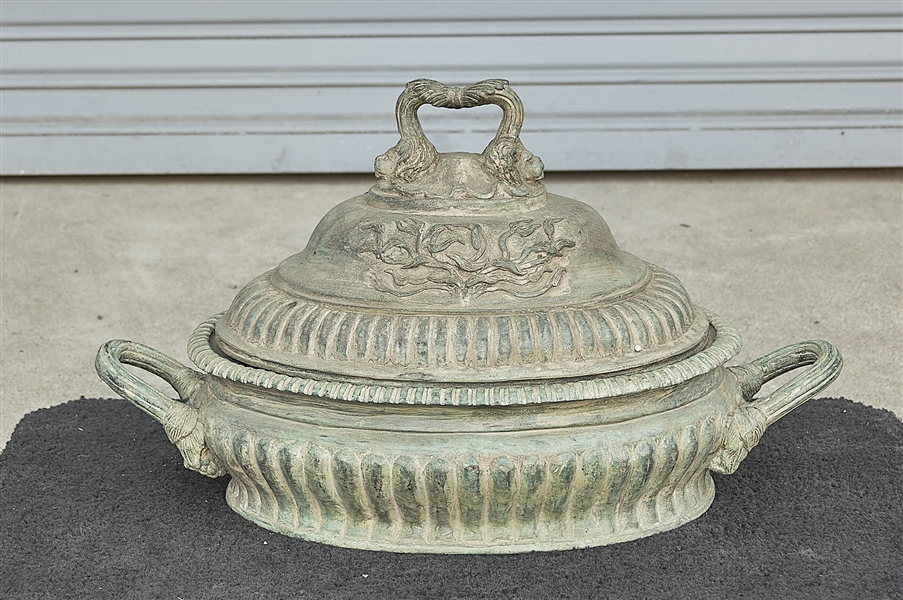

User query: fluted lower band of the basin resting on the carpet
[208,400,720,552]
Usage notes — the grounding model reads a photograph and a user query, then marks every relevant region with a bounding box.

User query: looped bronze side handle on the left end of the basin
[94,340,226,477]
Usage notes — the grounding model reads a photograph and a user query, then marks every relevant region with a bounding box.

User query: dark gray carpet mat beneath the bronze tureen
[0,399,903,600]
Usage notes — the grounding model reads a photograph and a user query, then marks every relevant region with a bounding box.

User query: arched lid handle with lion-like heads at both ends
[375,79,543,195]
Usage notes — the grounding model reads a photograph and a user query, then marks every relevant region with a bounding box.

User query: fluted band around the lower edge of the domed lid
[217,268,708,381]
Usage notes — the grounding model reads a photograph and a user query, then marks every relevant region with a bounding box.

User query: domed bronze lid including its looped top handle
[214,79,709,388]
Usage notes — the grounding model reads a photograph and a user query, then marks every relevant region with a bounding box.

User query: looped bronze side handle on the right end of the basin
[709,340,843,474]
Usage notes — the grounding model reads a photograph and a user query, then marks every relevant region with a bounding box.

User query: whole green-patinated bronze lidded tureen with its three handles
[96,80,841,553]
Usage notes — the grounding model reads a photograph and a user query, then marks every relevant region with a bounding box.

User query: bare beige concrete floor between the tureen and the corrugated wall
[0,170,903,447]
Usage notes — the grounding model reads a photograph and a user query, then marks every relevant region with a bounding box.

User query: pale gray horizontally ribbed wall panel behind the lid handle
[0,0,903,174]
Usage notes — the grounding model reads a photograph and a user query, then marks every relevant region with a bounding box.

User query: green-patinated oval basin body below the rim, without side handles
[198,370,739,552]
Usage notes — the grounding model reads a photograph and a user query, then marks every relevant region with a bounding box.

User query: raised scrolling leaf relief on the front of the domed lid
[353,218,576,303]
